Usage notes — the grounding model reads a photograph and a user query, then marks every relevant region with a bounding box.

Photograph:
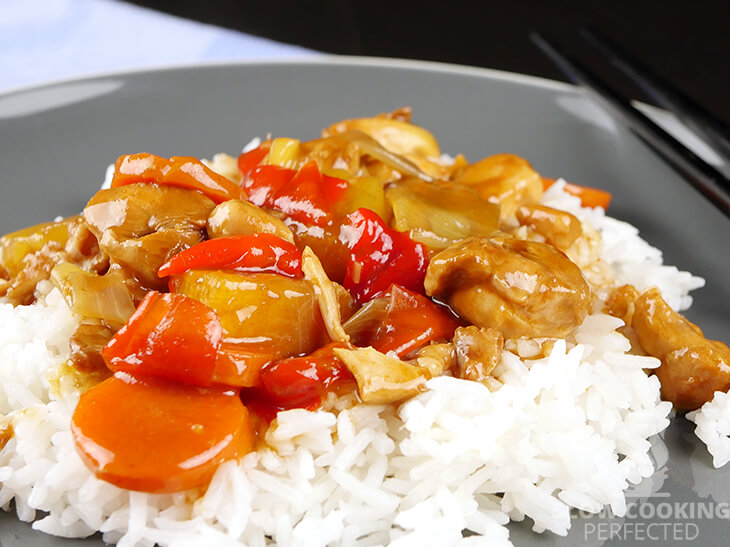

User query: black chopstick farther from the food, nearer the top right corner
[580,28,730,162]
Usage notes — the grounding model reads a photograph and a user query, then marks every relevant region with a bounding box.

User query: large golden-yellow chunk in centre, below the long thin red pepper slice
[170,270,326,359]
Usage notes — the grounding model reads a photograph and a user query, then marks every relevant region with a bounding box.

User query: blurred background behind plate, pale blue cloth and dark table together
[0,0,730,122]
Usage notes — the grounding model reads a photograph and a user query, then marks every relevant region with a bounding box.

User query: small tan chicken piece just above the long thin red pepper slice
[207,199,294,243]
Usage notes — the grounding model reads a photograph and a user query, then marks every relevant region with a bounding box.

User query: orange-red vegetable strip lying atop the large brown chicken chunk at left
[112,153,243,203]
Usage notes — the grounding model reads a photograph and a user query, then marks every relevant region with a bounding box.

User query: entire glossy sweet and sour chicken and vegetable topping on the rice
[0,108,730,492]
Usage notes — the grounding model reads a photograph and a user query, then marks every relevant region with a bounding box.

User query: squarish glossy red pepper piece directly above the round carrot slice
[101,291,222,386]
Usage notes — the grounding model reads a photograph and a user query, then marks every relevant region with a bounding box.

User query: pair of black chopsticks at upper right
[530,29,730,217]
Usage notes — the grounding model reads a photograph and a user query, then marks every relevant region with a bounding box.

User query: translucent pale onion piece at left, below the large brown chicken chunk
[51,262,134,328]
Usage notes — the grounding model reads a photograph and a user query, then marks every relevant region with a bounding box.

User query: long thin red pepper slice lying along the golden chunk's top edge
[157,233,303,278]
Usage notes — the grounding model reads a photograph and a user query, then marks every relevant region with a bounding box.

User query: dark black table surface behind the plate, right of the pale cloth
[133,0,730,123]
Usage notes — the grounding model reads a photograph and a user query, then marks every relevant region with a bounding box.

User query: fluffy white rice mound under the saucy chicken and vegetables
[0,183,730,547]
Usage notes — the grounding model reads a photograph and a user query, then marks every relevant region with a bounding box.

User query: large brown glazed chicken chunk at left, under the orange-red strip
[84,184,215,290]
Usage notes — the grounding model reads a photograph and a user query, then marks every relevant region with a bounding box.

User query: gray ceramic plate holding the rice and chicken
[0,58,730,547]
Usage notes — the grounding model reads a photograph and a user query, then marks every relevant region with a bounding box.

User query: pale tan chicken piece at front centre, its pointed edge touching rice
[332,348,428,404]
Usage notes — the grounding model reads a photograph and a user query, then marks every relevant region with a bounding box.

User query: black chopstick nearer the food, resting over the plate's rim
[530,33,730,217]
